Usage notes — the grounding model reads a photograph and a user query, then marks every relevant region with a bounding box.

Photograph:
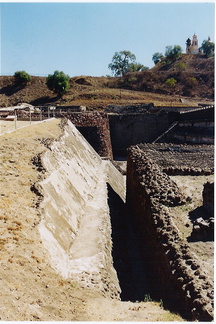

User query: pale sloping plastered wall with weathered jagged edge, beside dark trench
[39,121,125,298]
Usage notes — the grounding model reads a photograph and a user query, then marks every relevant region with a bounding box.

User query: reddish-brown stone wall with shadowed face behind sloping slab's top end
[56,112,113,160]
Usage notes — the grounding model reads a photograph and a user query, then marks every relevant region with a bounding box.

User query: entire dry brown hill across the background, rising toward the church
[0,54,214,110]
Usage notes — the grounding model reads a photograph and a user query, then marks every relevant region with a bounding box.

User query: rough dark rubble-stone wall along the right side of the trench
[127,146,213,321]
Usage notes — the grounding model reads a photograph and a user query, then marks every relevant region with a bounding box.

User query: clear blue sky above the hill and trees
[0,1,215,77]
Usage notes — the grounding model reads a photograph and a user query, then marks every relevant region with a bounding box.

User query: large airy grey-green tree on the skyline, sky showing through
[108,51,136,76]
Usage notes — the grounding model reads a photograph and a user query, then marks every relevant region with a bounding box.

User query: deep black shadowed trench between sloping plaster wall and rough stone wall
[107,184,155,302]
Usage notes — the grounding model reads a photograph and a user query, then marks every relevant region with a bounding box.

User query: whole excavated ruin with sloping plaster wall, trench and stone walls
[0,104,214,321]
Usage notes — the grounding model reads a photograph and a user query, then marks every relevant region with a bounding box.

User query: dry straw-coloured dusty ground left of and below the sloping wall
[0,119,185,321]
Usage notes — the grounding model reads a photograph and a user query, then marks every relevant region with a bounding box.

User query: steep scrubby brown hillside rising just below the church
[124,54,214,100]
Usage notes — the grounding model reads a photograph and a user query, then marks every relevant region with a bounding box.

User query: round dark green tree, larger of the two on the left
[46,71,70,96]
